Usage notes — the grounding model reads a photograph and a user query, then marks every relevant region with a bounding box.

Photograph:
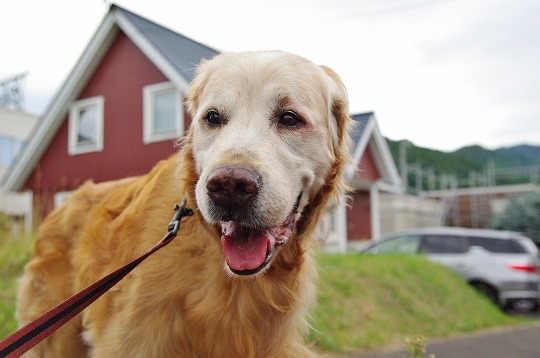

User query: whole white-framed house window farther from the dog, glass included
[68,97,104,155]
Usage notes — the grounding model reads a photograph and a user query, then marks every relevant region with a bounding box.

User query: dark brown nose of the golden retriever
[206,167,260,210]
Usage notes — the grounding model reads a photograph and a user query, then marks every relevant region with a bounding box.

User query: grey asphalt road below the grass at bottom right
[350,321,540,358]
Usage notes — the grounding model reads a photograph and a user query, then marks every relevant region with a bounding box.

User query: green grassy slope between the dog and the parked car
[310,254,525,352]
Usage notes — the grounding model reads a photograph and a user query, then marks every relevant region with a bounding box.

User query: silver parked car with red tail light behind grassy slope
[360,227,540,312]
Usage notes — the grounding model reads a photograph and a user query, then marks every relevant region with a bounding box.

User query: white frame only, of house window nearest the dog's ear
[143,82,184,144]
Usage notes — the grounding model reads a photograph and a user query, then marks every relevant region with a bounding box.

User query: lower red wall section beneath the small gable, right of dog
[347,191,371,240]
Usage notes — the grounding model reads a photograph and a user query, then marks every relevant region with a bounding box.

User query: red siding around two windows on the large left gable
[26,32,187,212]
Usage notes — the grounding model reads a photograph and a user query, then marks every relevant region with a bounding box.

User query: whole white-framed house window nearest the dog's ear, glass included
[143,82,183,143]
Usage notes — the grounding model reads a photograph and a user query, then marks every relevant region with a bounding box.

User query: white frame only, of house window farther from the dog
[68,96,105,155]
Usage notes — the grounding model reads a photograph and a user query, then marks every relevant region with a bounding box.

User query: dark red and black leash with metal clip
[0,199,193,358]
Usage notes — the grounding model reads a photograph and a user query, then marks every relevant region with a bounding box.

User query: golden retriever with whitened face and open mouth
[17,51,350,358]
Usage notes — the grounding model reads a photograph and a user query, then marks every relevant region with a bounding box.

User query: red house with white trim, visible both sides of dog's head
[1,5,400,251]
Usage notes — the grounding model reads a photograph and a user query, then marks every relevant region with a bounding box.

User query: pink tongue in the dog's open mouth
[221,221,275,271]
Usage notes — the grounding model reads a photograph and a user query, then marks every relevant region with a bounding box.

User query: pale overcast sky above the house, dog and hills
[0,0,540,150]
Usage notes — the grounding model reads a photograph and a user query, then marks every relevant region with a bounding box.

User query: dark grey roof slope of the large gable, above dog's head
[111,5,219,82]
